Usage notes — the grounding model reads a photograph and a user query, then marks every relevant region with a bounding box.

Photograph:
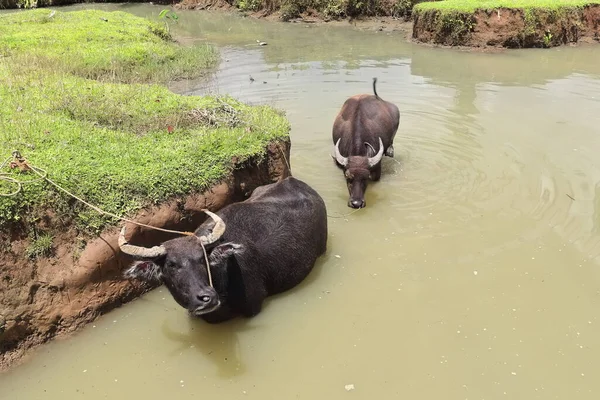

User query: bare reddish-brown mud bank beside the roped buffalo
[0,141,290,370]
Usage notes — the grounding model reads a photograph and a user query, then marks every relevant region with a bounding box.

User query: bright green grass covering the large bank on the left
[0,9,289,233]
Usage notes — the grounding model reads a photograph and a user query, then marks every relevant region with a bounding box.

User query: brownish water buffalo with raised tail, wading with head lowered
[332,78,400,208]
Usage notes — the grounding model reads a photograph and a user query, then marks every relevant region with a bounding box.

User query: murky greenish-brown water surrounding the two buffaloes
[0,5,600,400]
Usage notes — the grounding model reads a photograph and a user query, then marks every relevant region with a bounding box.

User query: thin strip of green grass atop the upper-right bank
[414,0,600,12]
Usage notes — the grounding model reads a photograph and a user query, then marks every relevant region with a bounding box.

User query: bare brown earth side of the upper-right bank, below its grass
[412,5,600,48]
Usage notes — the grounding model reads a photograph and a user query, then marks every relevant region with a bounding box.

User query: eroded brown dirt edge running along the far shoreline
[175,0,600,51]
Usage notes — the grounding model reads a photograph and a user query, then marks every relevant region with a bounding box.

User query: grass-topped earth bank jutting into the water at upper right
[413,0,600,47]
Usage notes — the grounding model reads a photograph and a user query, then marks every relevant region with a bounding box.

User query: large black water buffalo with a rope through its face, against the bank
[119,177,327,323]
